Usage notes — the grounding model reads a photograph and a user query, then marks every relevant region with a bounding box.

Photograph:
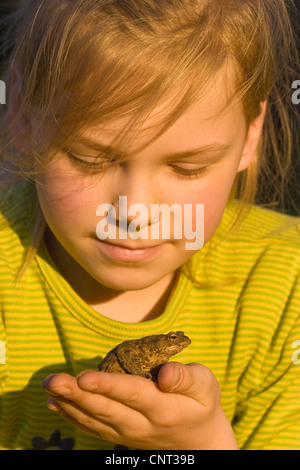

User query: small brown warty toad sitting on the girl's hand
[98,331,191,382]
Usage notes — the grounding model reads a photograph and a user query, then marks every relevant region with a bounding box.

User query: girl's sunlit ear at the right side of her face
[237,101,267,172]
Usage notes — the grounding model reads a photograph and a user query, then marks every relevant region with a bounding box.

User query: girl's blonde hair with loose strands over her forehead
[0,0,299,279]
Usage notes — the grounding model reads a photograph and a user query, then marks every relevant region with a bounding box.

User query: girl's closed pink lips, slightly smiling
[97,239,163,262]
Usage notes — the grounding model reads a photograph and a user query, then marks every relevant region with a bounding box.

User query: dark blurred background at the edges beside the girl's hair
[0,0,300,216]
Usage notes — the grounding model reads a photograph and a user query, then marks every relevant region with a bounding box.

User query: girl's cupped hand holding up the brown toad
[43,362,238,450]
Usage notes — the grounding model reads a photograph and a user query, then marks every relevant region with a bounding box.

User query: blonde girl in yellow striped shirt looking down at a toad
[0,0,300,449]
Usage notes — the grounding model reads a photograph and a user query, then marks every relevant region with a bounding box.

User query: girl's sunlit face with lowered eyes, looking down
[37,75,264,291]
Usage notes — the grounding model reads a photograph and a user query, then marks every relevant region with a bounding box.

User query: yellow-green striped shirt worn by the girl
[0,179,300,449]
